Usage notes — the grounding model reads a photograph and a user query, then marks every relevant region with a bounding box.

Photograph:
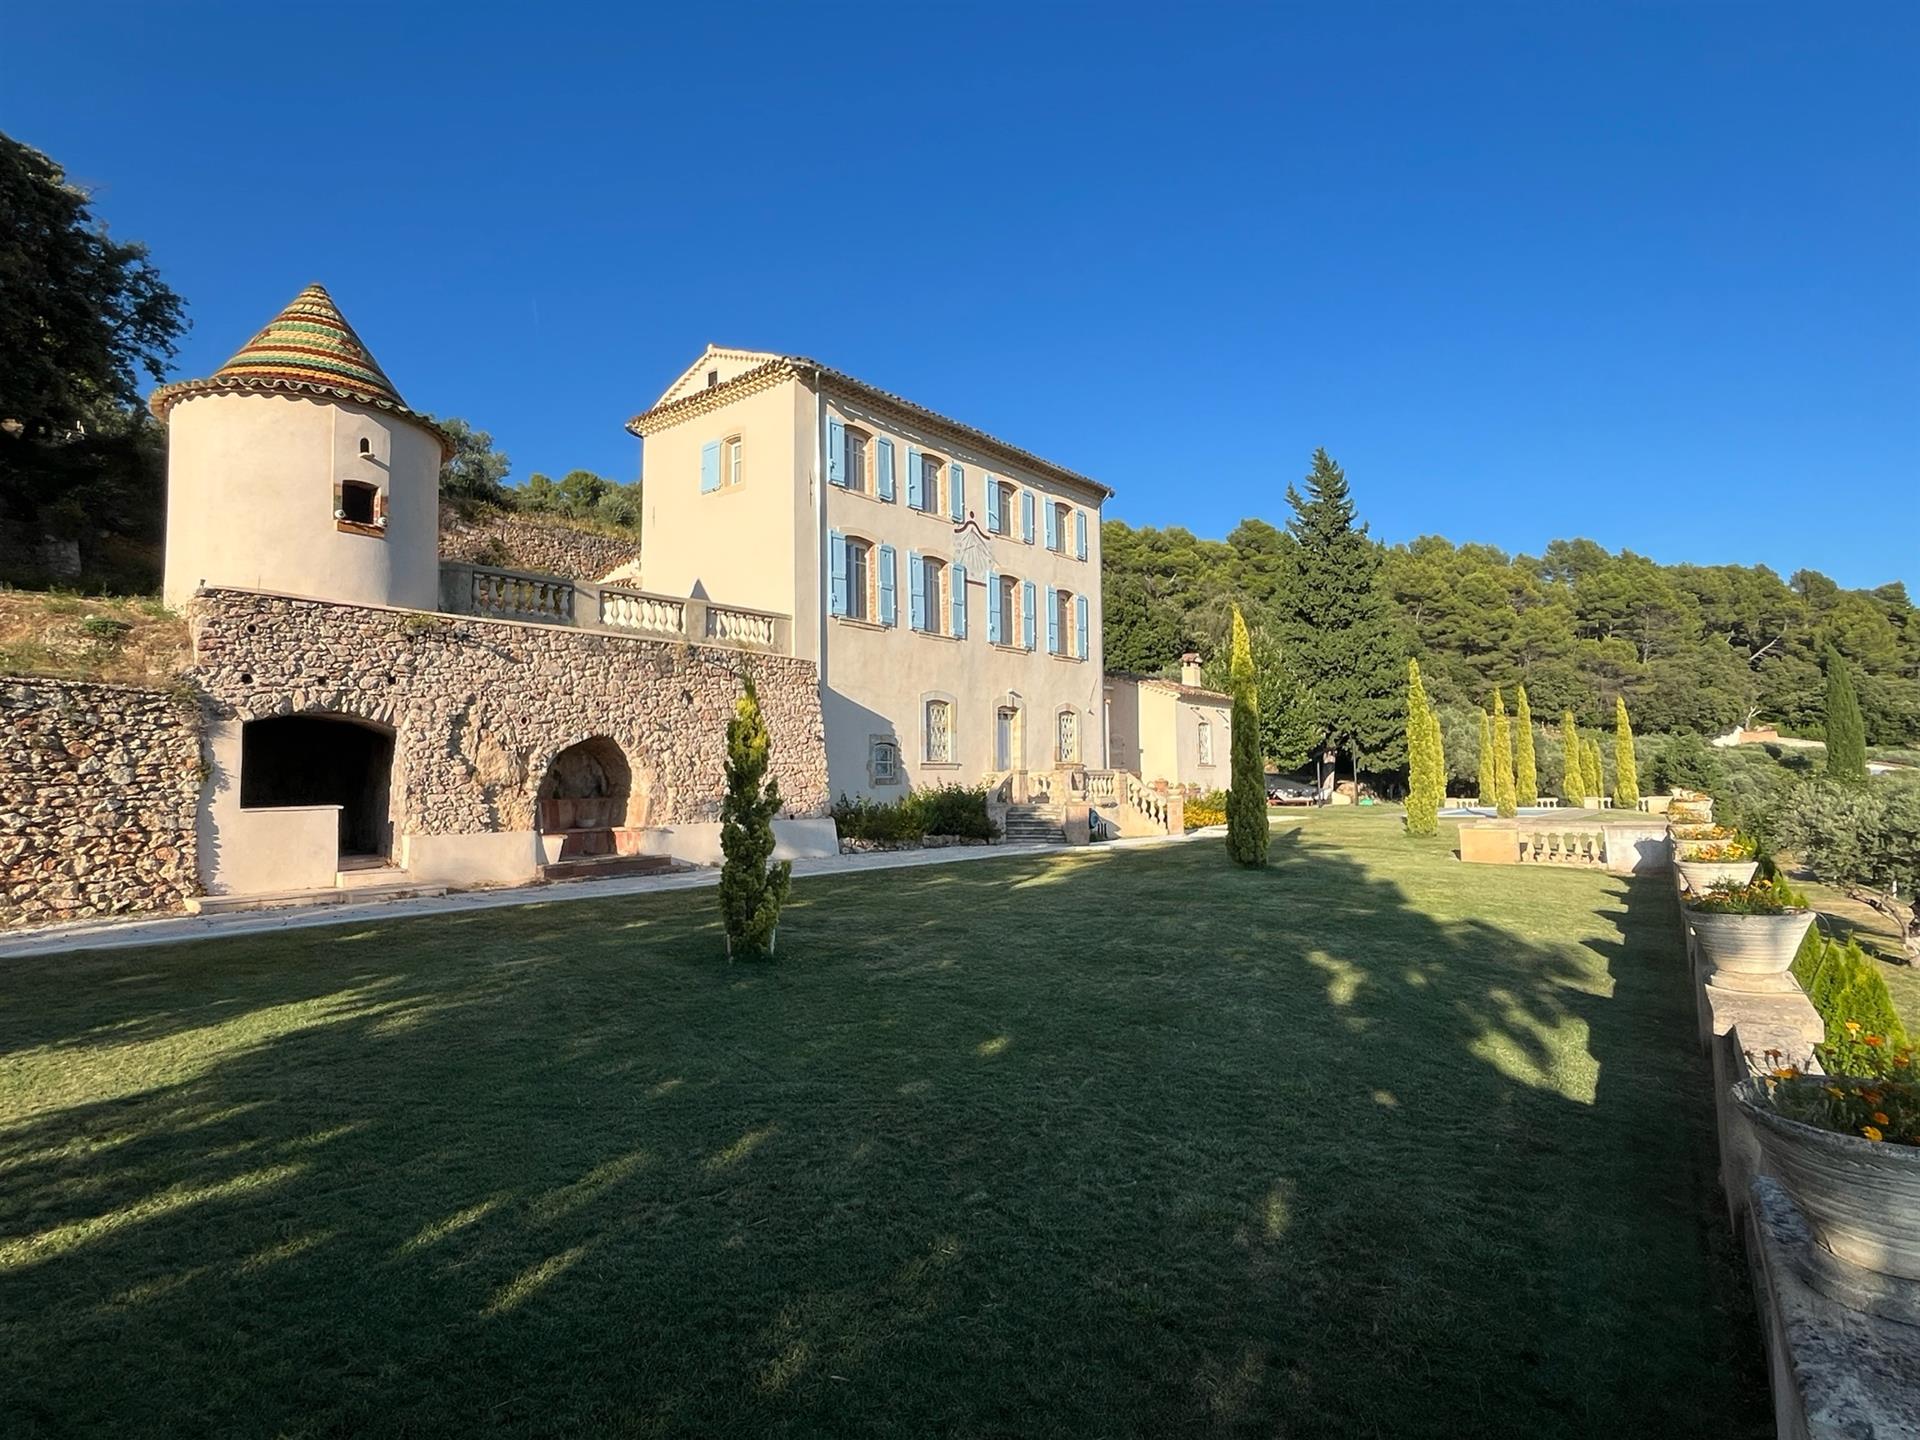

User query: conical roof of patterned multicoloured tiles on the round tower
[150,284,453,453]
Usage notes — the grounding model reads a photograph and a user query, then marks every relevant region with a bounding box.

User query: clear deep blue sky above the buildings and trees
[15,4,1920,586]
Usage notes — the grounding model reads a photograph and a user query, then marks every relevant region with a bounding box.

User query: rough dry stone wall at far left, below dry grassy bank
[0,678,200,927]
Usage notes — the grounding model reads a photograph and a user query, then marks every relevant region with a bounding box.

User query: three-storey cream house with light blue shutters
[628,348,1112,799]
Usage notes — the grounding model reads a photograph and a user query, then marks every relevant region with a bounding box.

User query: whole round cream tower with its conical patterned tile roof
[150,284,453,611]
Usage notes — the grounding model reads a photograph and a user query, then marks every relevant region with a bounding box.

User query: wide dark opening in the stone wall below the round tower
[240,714,394,856]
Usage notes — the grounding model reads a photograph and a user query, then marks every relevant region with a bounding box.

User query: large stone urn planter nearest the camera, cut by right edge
[1734,1077,1920,1281]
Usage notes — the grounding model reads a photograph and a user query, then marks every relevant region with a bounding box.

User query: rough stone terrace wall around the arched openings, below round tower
[190,589,828,835]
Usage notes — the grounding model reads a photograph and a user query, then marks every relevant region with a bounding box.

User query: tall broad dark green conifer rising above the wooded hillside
[1273,449,1405,781]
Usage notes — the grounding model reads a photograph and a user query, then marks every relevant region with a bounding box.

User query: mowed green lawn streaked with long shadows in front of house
[0,814,1770,1436]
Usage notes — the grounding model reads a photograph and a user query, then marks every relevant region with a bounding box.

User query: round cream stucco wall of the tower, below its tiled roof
[165,392,440,609]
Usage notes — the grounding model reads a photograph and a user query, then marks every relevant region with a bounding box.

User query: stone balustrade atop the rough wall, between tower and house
[440,561,793,655]
